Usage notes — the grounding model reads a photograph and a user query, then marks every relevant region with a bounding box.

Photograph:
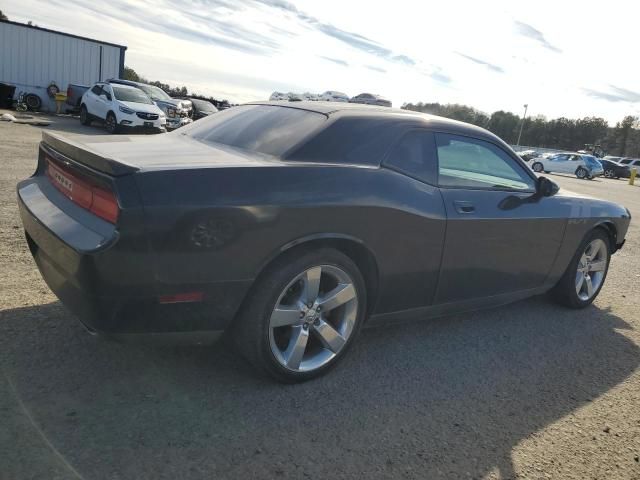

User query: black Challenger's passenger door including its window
[435,133,566,304]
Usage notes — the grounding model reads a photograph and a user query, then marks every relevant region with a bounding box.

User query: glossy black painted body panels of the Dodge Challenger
[18,102,630,340]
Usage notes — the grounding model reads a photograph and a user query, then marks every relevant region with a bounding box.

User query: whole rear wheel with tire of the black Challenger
[232,248,367,383]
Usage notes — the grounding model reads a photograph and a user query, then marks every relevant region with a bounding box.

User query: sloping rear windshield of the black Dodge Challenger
[182,105,327,157]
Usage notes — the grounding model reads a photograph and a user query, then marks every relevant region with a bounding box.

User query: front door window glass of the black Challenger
[435,133,535,190]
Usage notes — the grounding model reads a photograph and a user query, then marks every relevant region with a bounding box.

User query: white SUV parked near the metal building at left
[80,83,167,133]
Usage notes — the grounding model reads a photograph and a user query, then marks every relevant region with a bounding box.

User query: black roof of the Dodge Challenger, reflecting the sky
[245,101,506,145]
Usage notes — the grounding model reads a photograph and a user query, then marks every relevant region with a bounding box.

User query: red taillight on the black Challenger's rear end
[46,158,120,224]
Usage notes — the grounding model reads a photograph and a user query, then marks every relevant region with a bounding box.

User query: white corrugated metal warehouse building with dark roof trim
[0,21,127,111]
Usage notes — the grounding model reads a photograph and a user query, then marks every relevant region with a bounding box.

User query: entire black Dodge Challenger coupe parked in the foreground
[18,102,630,381]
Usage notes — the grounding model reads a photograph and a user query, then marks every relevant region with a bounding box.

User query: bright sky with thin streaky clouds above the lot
[0,0,640,125]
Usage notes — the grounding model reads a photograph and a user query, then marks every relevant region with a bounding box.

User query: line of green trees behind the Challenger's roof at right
[401,102,640,157]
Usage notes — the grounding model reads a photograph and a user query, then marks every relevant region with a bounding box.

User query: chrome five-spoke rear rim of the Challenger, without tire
[269,265,358,372]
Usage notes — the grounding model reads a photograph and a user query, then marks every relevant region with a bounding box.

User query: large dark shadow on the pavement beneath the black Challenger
[0,297,640,479]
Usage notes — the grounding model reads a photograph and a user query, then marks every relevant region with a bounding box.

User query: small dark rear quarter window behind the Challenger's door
[384,130,437,185]
